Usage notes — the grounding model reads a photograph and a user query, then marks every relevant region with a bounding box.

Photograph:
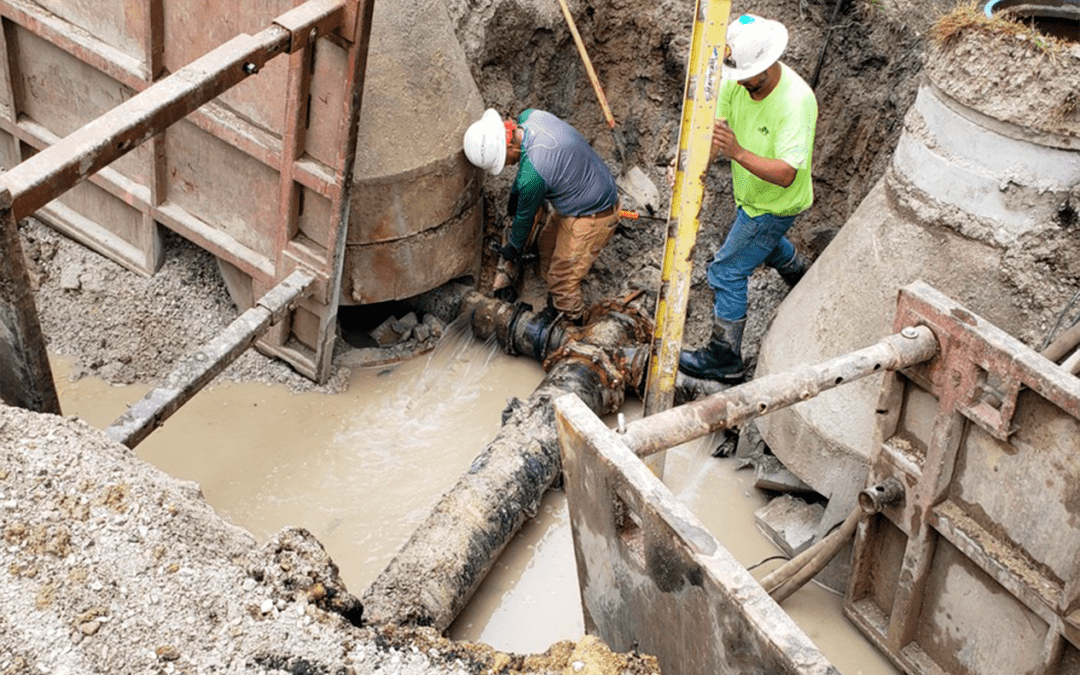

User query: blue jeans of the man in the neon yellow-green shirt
[708,207,796,321]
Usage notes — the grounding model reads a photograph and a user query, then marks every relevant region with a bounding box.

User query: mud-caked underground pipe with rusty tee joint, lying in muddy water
[362,292,651,632]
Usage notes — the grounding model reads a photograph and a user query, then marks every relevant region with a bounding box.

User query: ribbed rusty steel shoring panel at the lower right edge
[845,283,1080,675]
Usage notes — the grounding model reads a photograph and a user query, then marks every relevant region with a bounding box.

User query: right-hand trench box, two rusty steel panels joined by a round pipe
[555,282,1080,675]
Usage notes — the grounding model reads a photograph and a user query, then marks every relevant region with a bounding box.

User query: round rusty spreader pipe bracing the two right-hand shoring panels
[622,326,937,457]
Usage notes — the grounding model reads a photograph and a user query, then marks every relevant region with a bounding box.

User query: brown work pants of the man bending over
[529,203,619,319]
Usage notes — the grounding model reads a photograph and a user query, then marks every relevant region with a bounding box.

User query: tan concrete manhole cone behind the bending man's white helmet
[341,0,484,305]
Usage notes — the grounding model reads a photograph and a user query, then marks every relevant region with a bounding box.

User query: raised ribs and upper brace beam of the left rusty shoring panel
[0,0,374,381]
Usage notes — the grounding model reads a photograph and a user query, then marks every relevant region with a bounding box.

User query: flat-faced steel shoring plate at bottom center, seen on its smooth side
[555,388,839,675]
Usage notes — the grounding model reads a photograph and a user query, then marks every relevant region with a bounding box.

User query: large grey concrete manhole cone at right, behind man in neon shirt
[756,23,1080,535]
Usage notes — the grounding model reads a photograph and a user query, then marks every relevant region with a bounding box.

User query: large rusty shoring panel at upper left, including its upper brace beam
[0,0,374,381]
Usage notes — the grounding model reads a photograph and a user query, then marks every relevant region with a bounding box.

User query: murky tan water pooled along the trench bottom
[54,324,896,675]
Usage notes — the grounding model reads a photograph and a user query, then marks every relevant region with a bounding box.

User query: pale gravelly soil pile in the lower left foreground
[0,407,658,675]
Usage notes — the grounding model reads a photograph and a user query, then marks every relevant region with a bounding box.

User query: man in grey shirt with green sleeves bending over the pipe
[464,108,619,324]
